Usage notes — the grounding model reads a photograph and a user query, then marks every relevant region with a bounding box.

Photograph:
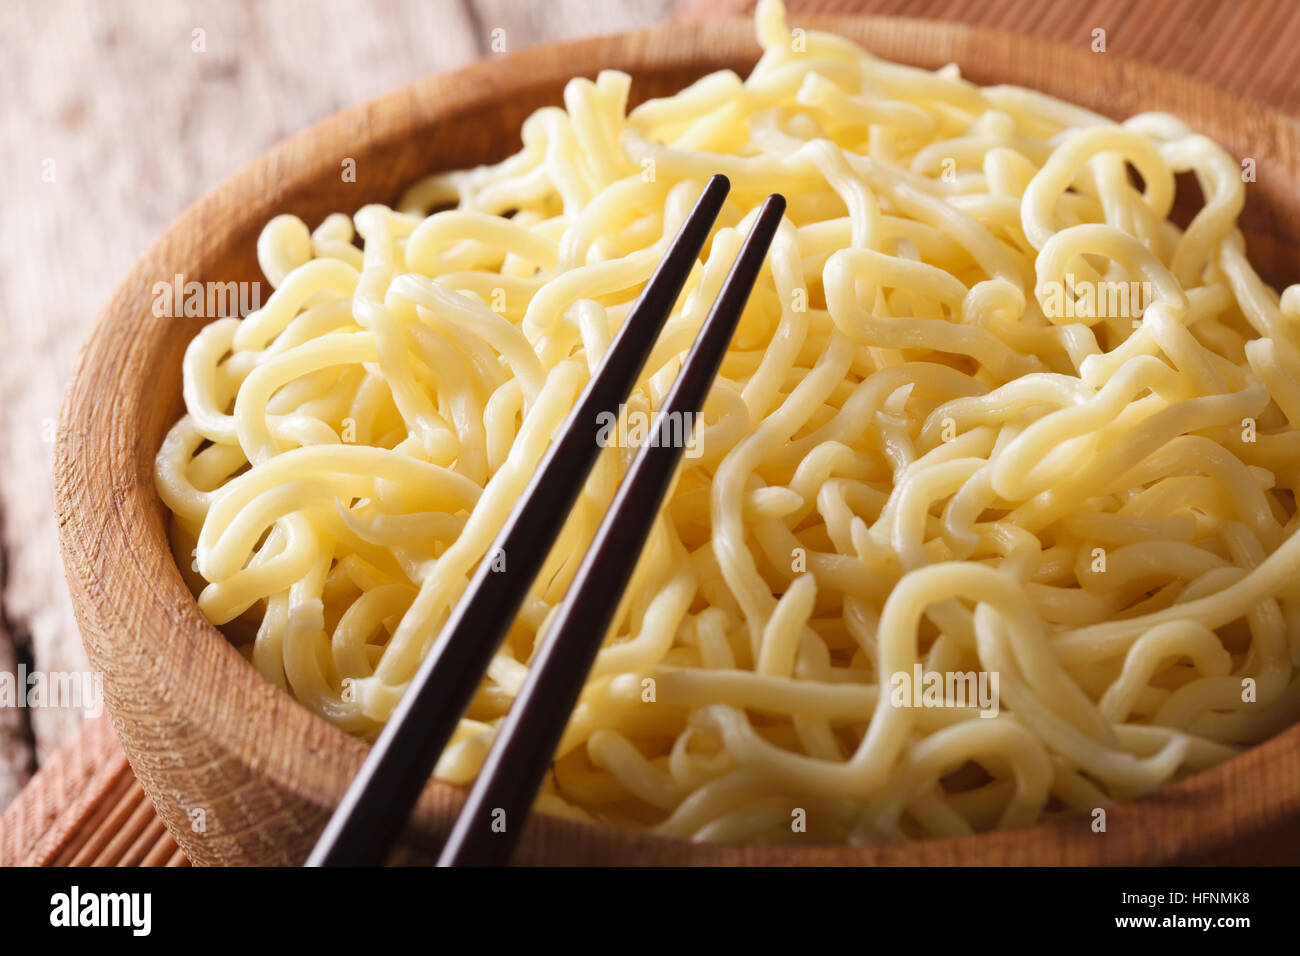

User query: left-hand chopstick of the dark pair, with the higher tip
[307,176,731,866]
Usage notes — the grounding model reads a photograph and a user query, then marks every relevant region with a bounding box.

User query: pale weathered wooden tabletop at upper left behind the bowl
[0,0,675,809]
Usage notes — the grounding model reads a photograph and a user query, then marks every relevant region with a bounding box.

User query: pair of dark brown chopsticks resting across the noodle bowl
[307,176,785,866]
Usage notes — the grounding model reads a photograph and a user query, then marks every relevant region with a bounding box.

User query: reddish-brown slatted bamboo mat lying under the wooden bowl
[10,0,1300,866]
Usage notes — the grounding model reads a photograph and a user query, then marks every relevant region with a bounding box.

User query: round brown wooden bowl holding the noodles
[55,18,1300,864]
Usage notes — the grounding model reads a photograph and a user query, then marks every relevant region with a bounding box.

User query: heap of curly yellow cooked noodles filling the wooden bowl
[157,0,1300,844]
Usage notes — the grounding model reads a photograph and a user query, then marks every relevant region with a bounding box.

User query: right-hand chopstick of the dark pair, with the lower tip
[438,195,785,866]
